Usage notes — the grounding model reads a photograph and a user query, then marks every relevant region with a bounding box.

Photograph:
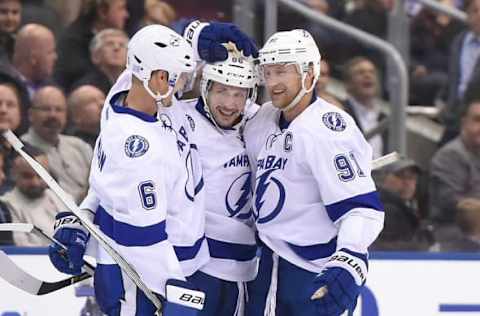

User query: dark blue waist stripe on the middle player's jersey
[207,238,257,261]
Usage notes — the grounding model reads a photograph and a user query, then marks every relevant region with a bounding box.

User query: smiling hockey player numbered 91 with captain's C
[244,30,384,316]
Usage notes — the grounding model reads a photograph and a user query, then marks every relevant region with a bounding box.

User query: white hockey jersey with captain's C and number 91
[244,98,383,272]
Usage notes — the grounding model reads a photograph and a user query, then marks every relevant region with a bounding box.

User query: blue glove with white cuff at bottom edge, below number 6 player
[163,279,205,316]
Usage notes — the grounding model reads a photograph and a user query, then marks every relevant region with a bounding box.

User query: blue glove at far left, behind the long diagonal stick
[48,212,90,275]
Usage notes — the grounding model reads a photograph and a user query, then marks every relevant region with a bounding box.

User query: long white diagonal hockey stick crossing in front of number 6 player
[3,130,162,314]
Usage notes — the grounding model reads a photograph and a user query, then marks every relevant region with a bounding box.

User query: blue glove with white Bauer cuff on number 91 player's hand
[309,248,368,316]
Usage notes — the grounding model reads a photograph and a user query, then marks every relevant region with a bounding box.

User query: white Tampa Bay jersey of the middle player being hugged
[176,98,258,281]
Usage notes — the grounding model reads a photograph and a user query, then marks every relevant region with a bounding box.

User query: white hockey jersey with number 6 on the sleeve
[88,72,209,294]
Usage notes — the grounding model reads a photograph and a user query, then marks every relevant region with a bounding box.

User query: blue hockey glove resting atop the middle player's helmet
[184,20,258,63]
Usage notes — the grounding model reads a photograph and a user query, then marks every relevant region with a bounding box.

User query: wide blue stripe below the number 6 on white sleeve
[93,206,167,247]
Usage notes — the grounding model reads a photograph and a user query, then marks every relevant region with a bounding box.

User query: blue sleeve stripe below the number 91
[325,191,383,222]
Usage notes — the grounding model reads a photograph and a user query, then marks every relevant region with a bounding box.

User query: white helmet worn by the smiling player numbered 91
[259,29,321,110]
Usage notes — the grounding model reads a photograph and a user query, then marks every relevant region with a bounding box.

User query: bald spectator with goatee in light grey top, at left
[22,86,93,202]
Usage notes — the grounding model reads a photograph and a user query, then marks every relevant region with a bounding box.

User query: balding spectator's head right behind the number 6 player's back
[67,85,105,149]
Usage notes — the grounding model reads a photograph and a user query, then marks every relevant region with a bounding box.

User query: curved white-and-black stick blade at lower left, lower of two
[0,250,91,295]
